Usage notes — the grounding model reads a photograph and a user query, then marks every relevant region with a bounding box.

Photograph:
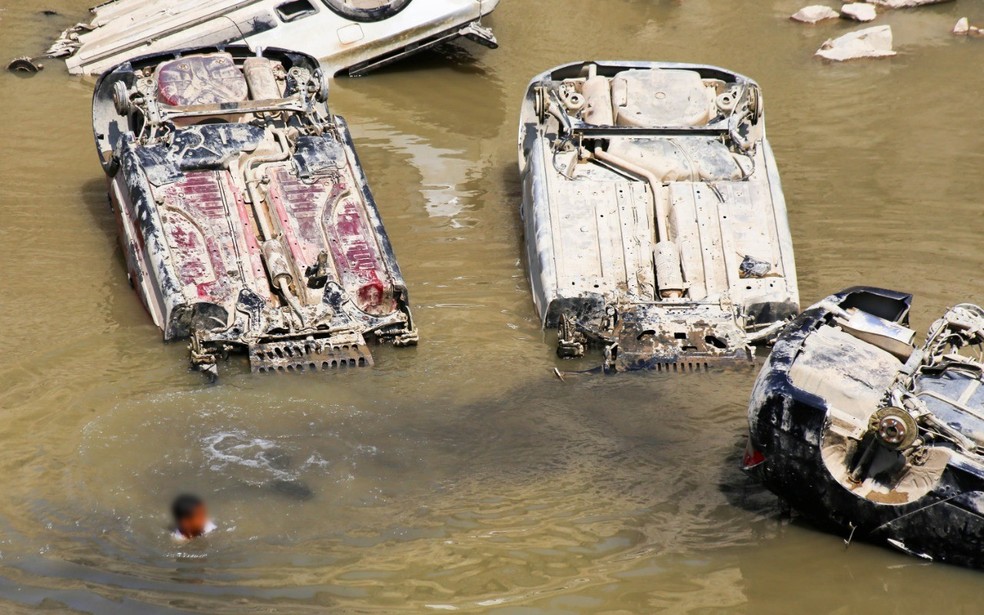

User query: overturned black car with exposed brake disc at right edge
[744,288,984,568]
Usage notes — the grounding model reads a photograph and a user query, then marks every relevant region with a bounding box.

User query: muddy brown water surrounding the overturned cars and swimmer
[0,0,984,615]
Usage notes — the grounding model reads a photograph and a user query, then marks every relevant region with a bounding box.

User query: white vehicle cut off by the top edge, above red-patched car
[48,0,499,76]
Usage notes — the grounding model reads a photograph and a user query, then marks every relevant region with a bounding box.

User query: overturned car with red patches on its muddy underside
[93,46,417,375]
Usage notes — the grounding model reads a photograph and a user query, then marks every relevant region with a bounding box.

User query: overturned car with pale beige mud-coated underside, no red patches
[519,62,799,371]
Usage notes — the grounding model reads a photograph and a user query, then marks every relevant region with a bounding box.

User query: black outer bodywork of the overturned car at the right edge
[745,287,984,568]
